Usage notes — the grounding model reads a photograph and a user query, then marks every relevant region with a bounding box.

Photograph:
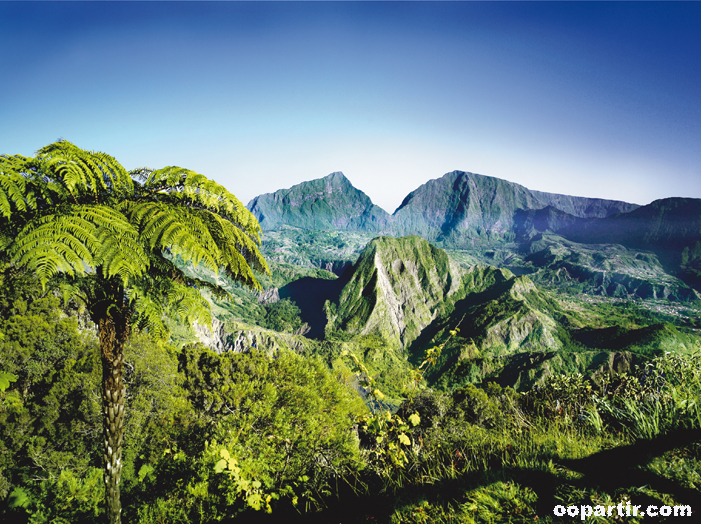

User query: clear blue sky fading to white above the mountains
[0,1,701,212]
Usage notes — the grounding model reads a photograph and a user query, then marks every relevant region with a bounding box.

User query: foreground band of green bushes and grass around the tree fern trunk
[0,260,701,523]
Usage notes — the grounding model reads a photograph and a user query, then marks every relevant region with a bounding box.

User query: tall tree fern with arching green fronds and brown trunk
[0,140,269,524]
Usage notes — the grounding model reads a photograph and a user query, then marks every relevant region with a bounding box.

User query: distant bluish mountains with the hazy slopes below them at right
[247,171,701,300]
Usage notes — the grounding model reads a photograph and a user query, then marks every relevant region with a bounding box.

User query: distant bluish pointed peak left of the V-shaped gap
[246,172,389,231]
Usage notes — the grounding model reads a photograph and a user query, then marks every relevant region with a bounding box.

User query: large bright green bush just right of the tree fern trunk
[144,346,365,522]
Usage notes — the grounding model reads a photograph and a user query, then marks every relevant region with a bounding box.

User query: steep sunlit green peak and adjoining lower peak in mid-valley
[327,236,563,376]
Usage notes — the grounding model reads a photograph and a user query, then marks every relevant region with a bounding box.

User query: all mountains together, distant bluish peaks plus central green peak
[174,171,701,399]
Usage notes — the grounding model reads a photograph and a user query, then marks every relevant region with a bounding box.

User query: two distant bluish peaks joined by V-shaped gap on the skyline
[247,171,639,239]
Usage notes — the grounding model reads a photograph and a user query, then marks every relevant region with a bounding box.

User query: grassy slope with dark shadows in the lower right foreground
[264,355,701,524]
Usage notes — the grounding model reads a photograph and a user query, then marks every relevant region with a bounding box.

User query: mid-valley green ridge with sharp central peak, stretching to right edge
[208,231,699,395]
